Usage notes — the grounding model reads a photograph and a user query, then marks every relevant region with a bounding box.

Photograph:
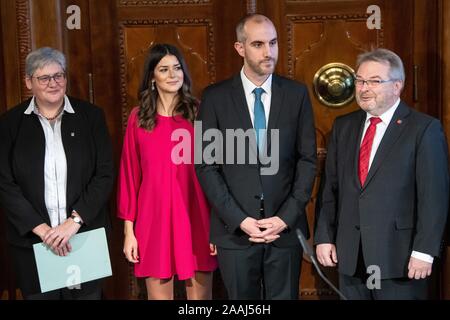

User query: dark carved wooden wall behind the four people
[0,0,450,299]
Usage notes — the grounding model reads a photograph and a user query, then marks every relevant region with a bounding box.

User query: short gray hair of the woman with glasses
[25,47,66,76]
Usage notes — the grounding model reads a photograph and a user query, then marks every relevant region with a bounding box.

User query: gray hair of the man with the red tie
[356,48,405,82]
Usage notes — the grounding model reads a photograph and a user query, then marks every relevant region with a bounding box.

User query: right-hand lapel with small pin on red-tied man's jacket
[363,102,410,188]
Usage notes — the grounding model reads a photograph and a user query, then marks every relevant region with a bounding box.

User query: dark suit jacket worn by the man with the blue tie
[196,74,316,249]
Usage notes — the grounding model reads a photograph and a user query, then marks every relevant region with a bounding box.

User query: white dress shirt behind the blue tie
[241,68,272,128]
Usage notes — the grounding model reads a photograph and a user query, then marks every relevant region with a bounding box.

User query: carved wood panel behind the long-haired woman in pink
[119,19,216,126]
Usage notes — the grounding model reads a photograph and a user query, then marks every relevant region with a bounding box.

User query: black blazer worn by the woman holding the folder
[0,98,113,247]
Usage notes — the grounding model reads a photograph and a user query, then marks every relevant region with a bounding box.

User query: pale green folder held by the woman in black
[33,228,112,293]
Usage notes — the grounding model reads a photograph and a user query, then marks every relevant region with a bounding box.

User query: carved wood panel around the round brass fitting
[287,14,383,159]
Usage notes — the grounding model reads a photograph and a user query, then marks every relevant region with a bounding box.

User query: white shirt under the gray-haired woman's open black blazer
[25,96,75,228]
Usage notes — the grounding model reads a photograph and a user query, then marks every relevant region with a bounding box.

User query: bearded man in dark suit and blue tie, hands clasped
[196,14,316,299]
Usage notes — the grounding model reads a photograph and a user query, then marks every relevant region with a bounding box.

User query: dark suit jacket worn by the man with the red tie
[315,102,449,279]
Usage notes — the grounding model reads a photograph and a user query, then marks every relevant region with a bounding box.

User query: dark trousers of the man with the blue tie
[217,243,302,300]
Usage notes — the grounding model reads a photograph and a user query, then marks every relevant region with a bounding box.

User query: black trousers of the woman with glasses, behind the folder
[10,246,103,300]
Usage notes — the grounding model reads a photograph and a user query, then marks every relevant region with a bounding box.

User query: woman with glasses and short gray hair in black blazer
[0,47,113,300]
